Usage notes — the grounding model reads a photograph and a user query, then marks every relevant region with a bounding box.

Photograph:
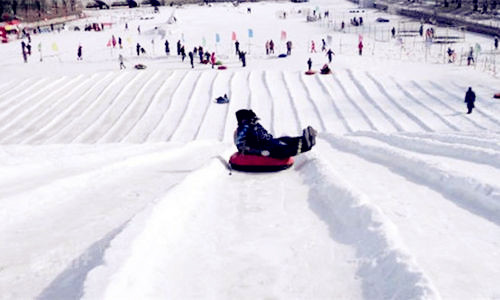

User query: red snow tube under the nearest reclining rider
[229,152,294,172]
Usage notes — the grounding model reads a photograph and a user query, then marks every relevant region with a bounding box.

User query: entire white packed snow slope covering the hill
[0,0,500,299]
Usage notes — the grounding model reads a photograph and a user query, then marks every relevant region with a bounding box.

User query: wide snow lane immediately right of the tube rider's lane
[318,134,500,299]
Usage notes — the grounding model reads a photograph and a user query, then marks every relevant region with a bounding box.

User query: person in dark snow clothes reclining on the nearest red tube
[234,109,317,158]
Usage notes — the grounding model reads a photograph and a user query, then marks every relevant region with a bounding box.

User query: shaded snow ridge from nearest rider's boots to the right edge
[322,133,500,226]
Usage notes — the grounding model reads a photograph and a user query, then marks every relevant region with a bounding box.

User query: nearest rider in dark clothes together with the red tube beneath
[229,109,317,172]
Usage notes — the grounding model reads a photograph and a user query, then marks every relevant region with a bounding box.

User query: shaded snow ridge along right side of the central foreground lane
[300,157,439,299]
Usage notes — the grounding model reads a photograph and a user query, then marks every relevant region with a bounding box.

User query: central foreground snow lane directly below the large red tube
[83,156,362,299]
